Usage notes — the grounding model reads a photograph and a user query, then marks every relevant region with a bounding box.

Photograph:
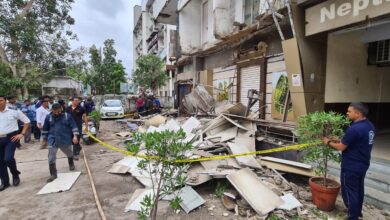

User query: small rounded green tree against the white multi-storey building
[133,54,169,93]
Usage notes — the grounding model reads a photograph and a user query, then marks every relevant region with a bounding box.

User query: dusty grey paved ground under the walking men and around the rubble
[0,121,222,220]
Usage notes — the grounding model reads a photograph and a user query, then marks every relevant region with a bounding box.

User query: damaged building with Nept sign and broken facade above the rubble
[135,0,390,211]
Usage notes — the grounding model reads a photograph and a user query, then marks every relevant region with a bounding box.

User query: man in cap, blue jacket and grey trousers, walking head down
[42,103,79,182]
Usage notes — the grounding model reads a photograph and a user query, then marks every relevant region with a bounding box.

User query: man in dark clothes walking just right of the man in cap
[66,97,88,160]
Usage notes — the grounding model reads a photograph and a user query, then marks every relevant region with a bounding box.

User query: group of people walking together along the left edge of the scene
[0,94,95,191]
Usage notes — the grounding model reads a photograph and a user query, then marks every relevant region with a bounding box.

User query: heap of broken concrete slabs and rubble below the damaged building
[108,111,313,218]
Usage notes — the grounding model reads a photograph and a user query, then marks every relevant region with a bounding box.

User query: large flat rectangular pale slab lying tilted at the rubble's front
[227,168,283,216]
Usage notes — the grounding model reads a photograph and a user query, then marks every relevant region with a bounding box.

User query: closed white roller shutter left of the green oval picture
[240,66,260,112]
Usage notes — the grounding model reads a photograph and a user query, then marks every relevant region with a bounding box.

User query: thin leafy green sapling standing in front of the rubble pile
[127,130,192,219]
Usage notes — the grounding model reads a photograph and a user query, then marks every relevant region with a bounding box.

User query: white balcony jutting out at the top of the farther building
[152,0,177,25]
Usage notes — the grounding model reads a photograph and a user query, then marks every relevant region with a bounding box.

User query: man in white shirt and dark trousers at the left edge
[0,95,30,191]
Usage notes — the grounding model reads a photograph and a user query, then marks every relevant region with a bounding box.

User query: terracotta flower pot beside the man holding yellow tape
[309,177,340,212]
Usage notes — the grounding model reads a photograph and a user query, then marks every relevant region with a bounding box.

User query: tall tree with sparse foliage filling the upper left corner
[0,0,76,97]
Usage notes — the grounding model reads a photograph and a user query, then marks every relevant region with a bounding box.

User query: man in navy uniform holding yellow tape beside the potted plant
[323,103,375,220]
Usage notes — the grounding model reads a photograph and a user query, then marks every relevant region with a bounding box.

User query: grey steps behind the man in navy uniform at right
[329,158,390,210]
